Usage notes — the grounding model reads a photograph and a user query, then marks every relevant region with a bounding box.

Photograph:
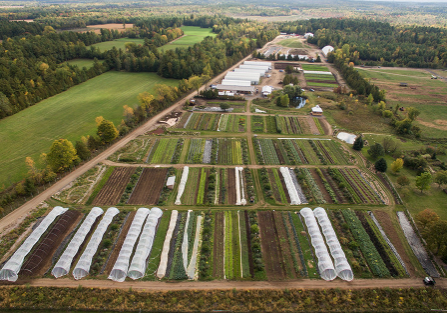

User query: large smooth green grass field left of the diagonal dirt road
[0,71,178,187]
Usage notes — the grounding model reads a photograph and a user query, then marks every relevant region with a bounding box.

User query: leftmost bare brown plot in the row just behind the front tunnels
[92,167,135,206]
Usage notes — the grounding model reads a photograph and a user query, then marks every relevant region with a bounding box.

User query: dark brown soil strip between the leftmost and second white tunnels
[19,211,82,276]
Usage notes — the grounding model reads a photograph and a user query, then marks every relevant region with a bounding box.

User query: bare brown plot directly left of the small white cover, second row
[127,168,168,205]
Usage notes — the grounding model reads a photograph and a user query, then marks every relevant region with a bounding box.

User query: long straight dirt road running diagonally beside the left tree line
[0,54,251,234]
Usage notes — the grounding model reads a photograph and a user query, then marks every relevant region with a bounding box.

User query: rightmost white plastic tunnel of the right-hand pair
[314,208,354,281]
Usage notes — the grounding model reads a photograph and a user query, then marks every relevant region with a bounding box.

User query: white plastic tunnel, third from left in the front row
[73,208,120,280]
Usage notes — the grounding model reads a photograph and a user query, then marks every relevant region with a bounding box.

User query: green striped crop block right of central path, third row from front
[253,138,350,165]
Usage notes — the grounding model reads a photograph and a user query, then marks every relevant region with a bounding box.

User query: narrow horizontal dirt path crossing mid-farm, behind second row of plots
[102,160,358,169]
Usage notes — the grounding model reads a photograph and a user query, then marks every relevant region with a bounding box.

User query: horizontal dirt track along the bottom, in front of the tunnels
[5,278,447,291]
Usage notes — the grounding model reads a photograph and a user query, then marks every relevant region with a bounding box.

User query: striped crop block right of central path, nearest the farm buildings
[251,115,328,135]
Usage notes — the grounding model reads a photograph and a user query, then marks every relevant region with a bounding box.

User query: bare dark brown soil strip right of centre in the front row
[258,211,286,280]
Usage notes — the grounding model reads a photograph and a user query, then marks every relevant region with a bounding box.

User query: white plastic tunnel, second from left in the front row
[51,207,104,278]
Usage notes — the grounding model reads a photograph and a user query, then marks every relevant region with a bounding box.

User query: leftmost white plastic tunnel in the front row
[0,206,68,282]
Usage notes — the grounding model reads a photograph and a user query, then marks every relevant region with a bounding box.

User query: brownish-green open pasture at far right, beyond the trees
[357,68,447,138]
